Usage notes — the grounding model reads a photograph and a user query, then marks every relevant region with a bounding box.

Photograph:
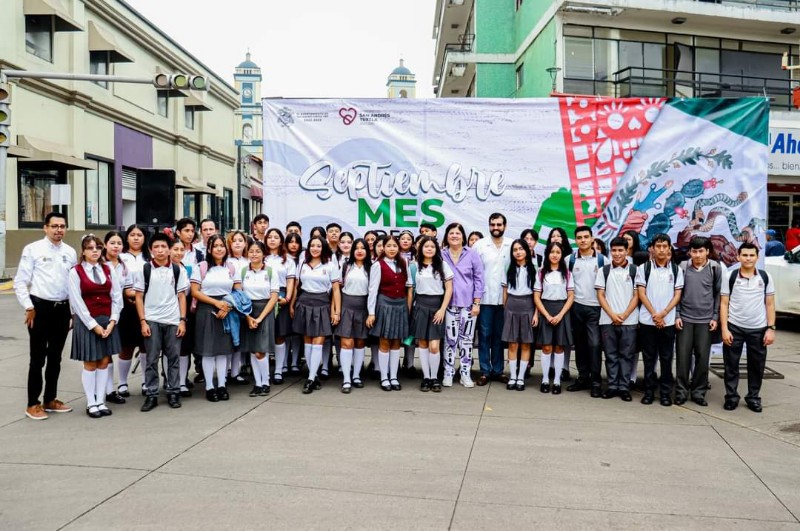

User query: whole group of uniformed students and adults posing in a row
[15,213,775,420]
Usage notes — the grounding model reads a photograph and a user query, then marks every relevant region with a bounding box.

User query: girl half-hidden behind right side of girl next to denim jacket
[264,228,300,385]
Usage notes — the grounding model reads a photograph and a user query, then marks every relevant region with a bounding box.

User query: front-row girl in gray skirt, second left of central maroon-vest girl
[290,237,341,394]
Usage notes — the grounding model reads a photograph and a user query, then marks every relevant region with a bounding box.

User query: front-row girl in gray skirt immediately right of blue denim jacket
[240,240,280,396]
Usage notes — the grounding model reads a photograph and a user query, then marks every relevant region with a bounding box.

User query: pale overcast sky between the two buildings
[127,0,435,98]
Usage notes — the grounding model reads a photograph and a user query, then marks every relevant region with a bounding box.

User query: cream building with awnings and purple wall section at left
[0,0,239,272]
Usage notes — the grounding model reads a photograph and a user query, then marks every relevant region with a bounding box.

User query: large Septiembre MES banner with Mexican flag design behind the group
[263,97,768,266]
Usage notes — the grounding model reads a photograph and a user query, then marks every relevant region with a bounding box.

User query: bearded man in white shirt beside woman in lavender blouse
[473,212,513,385]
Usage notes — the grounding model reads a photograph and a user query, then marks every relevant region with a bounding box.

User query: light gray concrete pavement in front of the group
[0,295,800,530]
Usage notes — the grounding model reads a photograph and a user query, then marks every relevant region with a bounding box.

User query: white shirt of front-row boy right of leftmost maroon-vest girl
[133,262,191,326]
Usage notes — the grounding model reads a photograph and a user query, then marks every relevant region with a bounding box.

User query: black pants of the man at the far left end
[28,297,71,407]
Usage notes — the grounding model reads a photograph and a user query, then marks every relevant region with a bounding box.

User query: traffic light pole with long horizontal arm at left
[0,70,209,278]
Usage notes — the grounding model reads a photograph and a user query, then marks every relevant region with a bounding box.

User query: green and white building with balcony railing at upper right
[433,0,800,237]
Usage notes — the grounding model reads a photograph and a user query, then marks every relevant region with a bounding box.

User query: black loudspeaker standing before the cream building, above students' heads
[136,170,175,227]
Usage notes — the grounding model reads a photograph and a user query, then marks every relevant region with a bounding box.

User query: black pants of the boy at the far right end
[722,324,767,402]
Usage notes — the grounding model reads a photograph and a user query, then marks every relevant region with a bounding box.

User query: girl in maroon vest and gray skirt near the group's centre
[367,235,413,391]
